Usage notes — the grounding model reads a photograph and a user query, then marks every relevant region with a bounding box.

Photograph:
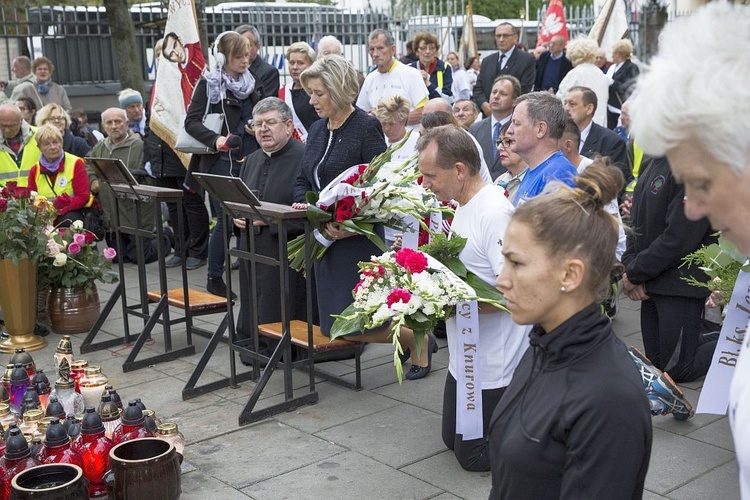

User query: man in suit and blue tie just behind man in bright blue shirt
[469,75,521,181]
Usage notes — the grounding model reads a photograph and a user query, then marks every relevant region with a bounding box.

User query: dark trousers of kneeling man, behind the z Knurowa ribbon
[443,371,505,472]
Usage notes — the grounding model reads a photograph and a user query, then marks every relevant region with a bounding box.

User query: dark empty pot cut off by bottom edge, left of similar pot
[10,464,89,500]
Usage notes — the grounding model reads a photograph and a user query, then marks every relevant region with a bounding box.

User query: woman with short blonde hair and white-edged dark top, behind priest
[279,42,319,143]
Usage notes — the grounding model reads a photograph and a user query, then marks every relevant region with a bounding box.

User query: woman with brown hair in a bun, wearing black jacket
[489,160,651,499]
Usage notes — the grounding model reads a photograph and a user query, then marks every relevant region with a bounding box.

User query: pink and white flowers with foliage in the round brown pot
[37,221,117,294]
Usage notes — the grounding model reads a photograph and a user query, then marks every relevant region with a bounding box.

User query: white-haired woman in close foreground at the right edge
[630,2,750,499]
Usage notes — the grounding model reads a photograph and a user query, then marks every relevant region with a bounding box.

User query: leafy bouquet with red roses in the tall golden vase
[0,181,55,265]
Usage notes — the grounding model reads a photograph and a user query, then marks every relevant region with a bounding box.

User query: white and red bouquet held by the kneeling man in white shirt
[331,237,505,383]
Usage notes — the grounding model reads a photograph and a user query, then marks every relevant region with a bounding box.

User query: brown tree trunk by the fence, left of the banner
[104,0,145,95]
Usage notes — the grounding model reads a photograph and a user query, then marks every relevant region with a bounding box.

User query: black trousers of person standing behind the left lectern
[155,176,209,259]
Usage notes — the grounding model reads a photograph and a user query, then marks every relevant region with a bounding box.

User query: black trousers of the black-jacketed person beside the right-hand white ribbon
[641,295,716,382]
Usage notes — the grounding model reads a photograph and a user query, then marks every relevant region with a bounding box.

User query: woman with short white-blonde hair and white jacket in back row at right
[557,38,612,127]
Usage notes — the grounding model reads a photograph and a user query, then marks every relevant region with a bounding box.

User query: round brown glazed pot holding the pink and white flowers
[47,285,101,335]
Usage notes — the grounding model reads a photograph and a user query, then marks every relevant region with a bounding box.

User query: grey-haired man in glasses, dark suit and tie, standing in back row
[473,23,536,116]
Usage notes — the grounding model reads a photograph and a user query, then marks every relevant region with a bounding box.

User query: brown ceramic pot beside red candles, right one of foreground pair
[104,438,182,500]
